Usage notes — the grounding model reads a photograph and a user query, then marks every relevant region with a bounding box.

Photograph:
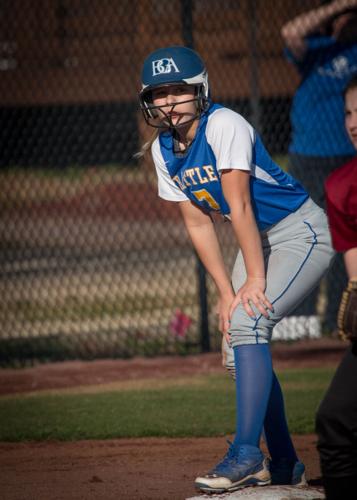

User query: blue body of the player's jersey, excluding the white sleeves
[160,105,308,229]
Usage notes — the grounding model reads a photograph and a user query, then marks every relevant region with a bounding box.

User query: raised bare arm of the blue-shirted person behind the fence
[281,0,356,60]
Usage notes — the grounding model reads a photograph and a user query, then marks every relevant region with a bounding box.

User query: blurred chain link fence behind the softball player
[0,0,342,366]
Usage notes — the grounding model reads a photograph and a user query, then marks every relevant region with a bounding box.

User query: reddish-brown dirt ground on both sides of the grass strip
[0,339,346,500]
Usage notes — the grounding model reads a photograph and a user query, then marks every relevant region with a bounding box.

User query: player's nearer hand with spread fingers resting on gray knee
[229,278,274,319]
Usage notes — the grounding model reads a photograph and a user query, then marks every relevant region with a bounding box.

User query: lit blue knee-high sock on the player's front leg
[234,344,273,446]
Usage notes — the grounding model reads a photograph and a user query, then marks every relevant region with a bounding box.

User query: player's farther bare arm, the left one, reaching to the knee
[179,201,234,334]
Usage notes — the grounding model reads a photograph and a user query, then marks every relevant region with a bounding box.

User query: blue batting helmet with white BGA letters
[139,46,209,127]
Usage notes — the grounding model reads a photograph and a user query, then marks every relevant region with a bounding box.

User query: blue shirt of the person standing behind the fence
[286,36,357,157]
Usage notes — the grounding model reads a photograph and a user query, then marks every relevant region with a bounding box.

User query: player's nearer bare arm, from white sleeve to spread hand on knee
[221,170,273,318]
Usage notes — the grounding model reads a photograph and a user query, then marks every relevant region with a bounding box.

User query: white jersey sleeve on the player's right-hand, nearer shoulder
[206,108,255,171]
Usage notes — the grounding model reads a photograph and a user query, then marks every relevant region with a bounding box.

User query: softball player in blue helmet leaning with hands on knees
[140,46,333,493]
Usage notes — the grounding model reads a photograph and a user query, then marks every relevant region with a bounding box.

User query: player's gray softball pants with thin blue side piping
[227,195,334,352]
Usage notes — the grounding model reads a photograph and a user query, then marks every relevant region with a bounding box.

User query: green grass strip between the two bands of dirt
[0,368,334,442]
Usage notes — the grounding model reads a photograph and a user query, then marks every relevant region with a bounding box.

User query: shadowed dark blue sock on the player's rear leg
[264,372,297,462]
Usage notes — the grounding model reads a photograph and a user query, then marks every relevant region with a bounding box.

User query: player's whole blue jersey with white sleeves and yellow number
[152,104,308,230]
